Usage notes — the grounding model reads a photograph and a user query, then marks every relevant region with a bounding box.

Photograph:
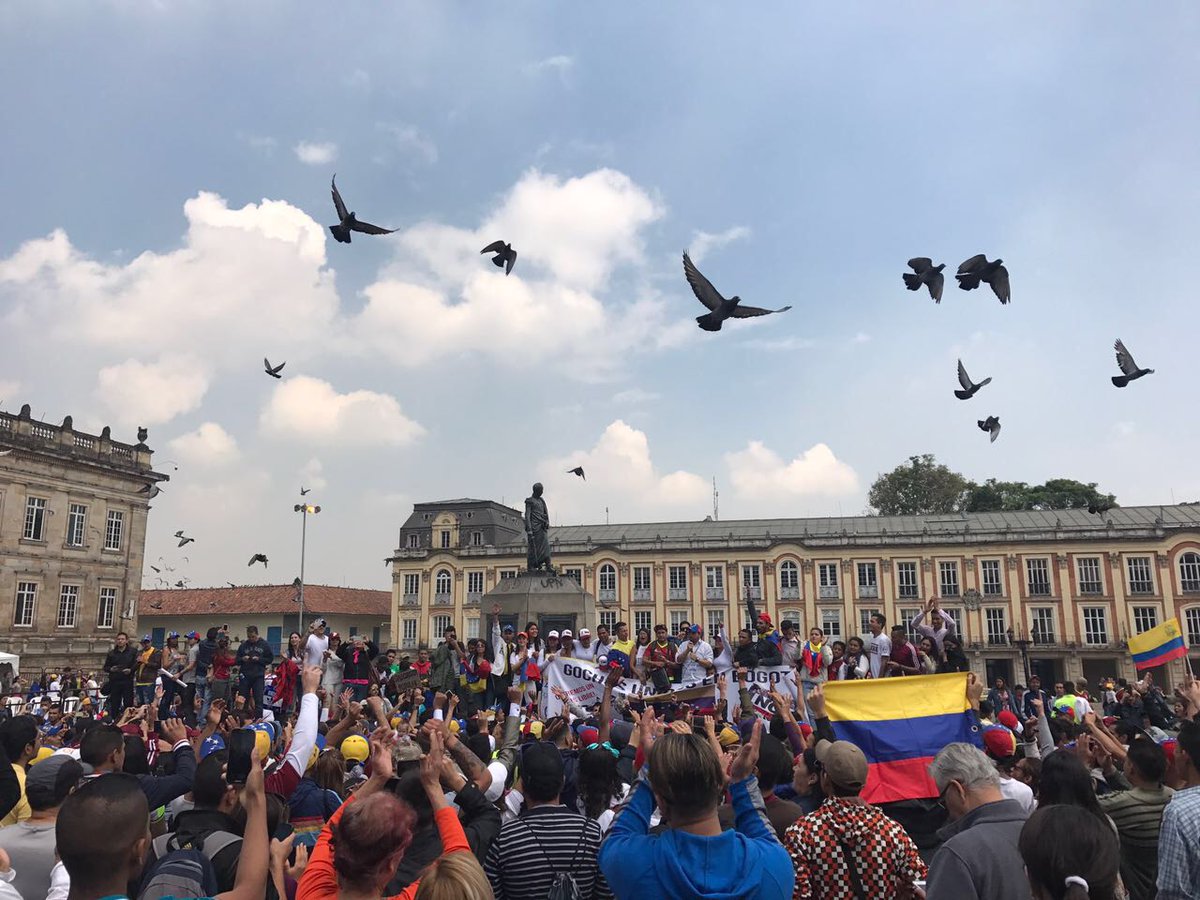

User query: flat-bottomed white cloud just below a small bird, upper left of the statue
[259,376,425,448]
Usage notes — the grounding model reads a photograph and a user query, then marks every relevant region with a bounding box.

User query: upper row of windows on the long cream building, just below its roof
[404,551,1200,600]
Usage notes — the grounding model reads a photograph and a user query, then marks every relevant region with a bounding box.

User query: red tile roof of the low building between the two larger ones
[138,584,391,620]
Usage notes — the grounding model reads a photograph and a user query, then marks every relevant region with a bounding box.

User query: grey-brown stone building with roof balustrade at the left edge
[0,404,167,677]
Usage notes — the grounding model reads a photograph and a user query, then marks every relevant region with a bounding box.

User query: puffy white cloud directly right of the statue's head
[538,419,712,522]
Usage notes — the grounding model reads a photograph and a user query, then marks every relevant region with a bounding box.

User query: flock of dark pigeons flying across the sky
[138,173,1154,592]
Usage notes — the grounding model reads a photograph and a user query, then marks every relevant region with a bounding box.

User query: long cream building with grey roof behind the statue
[391,500,1200,682]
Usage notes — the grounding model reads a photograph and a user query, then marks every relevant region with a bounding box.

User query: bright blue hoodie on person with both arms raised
[600,775,796,900]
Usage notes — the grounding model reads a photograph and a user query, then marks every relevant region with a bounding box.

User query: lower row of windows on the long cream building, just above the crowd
[401,606,1200,647]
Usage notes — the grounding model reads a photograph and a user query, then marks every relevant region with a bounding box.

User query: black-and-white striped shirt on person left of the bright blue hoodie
[484,805,612,900]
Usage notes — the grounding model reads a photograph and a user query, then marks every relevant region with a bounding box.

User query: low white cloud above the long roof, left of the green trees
[725,440,858,499]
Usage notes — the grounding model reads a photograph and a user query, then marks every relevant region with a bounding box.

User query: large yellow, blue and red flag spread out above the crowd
[824,673,980,803]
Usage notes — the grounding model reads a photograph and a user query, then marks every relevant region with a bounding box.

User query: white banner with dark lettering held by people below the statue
[541,659,797,720]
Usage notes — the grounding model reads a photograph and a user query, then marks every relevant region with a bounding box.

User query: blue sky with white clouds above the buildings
[0,0,1200,588]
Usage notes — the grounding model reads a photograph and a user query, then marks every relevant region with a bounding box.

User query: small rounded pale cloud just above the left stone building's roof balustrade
[96,355,209,425]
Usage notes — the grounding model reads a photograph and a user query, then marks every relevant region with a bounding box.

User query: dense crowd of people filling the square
[0,604,1200,900]
